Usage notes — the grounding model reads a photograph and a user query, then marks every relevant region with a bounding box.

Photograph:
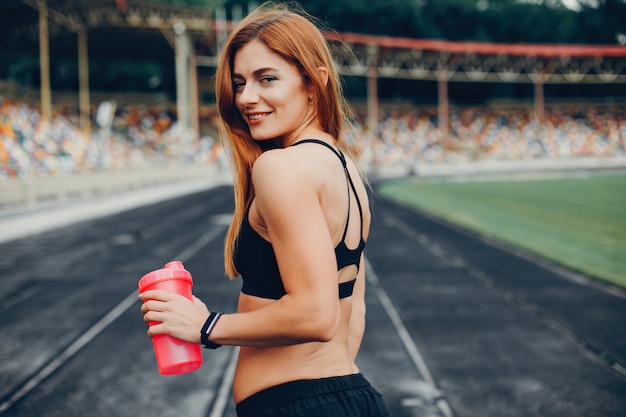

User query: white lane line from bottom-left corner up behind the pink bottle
[0,227,222,414]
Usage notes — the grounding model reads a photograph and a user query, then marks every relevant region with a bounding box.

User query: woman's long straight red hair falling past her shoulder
[215,3,349,278]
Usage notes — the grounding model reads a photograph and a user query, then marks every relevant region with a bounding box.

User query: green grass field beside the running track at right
[378,174,626,287]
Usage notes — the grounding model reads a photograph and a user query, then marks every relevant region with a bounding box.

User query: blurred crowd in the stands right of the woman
[359,105,626,166]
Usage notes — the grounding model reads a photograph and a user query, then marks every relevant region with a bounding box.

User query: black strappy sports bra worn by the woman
[233,139,365,300]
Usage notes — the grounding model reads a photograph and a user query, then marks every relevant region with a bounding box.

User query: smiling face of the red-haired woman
[233,40,314,145]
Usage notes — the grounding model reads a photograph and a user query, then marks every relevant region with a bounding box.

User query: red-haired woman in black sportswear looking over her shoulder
[141,6,389,417]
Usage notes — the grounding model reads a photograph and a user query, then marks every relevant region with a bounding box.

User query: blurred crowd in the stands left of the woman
[0,97,221,179]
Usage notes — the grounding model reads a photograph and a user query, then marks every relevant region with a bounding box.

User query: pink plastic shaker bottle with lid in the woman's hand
[138,261,202,375]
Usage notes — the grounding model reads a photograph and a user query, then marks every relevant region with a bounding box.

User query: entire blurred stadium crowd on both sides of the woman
[0,97,626,179]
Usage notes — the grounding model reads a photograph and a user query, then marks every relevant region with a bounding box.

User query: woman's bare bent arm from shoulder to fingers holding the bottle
[142,150,341,346]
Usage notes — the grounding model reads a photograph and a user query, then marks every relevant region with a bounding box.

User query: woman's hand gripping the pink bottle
[139,290,209,343]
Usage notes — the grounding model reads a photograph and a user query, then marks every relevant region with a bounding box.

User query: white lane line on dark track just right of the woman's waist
[365,258,454,417]
